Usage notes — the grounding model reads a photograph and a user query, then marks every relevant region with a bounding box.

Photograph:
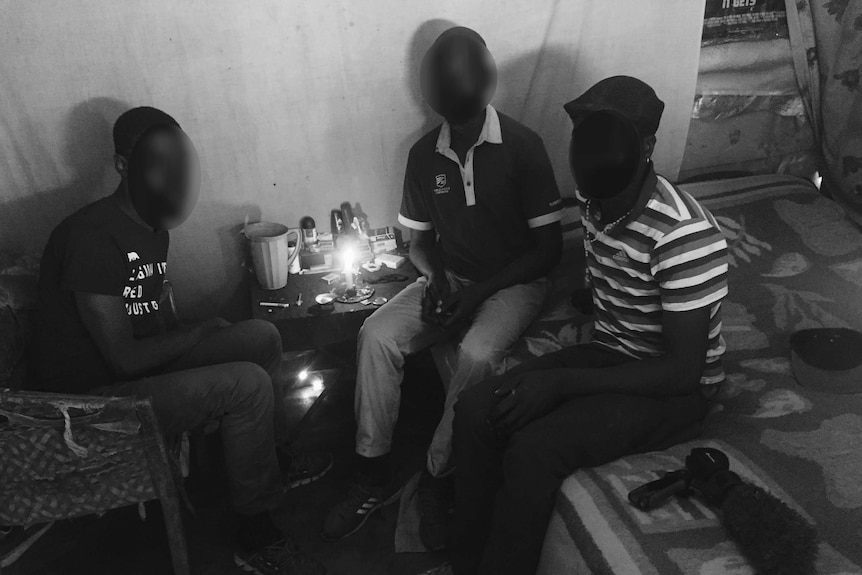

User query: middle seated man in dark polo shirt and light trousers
[324,28,562,548]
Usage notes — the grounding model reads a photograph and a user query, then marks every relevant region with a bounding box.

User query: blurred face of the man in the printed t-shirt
[127,127,200,229]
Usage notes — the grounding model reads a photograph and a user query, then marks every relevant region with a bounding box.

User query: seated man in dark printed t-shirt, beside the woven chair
[34,108,331,573]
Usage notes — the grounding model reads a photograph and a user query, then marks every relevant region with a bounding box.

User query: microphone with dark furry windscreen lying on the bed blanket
[629,447,818,575]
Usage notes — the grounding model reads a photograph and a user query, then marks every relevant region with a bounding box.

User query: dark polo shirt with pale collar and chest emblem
[398,106,562,281]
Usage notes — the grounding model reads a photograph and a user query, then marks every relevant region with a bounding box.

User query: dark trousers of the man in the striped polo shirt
[453,344,708,575]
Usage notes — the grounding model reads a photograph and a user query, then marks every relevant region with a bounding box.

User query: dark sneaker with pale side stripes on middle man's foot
[321,474,401,541]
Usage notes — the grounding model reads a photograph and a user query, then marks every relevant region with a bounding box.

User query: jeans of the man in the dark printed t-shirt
[97,320,288,515]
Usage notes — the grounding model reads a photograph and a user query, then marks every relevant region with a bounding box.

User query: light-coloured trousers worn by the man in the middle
[355,272,549,476]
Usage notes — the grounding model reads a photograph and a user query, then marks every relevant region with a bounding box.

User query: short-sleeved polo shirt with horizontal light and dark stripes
[578,170,728,384]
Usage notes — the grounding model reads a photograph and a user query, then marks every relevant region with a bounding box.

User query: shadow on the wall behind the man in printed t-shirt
[0,98,129,256]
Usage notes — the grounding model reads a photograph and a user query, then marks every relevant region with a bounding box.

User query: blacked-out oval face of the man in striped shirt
[569,112,646,200]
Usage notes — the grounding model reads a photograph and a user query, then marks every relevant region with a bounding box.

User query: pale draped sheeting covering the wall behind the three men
[0,0,703,313]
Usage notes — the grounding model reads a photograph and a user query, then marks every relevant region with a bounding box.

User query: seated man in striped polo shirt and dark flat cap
[453,76,727,575]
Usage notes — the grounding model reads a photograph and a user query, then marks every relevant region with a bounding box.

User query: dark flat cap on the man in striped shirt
[563,76,664,138]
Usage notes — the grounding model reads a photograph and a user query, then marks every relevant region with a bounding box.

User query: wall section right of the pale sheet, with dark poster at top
[680,0,819,180]
